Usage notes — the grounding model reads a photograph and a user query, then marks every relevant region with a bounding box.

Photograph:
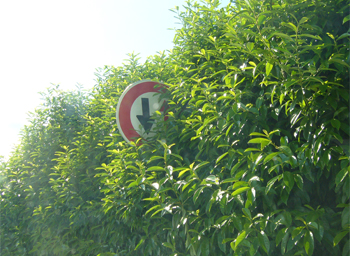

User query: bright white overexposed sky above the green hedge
[0,0,229,158]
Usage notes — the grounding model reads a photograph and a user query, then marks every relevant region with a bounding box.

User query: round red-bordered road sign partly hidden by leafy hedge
[117,80,166,142]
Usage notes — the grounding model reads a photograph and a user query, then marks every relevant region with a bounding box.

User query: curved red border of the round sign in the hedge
[117,80,165,142]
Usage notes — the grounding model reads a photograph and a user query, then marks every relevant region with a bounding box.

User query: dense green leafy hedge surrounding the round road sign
[0,0,350,256]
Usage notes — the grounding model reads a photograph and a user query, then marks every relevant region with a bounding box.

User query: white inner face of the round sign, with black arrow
[130,92,165,138]
